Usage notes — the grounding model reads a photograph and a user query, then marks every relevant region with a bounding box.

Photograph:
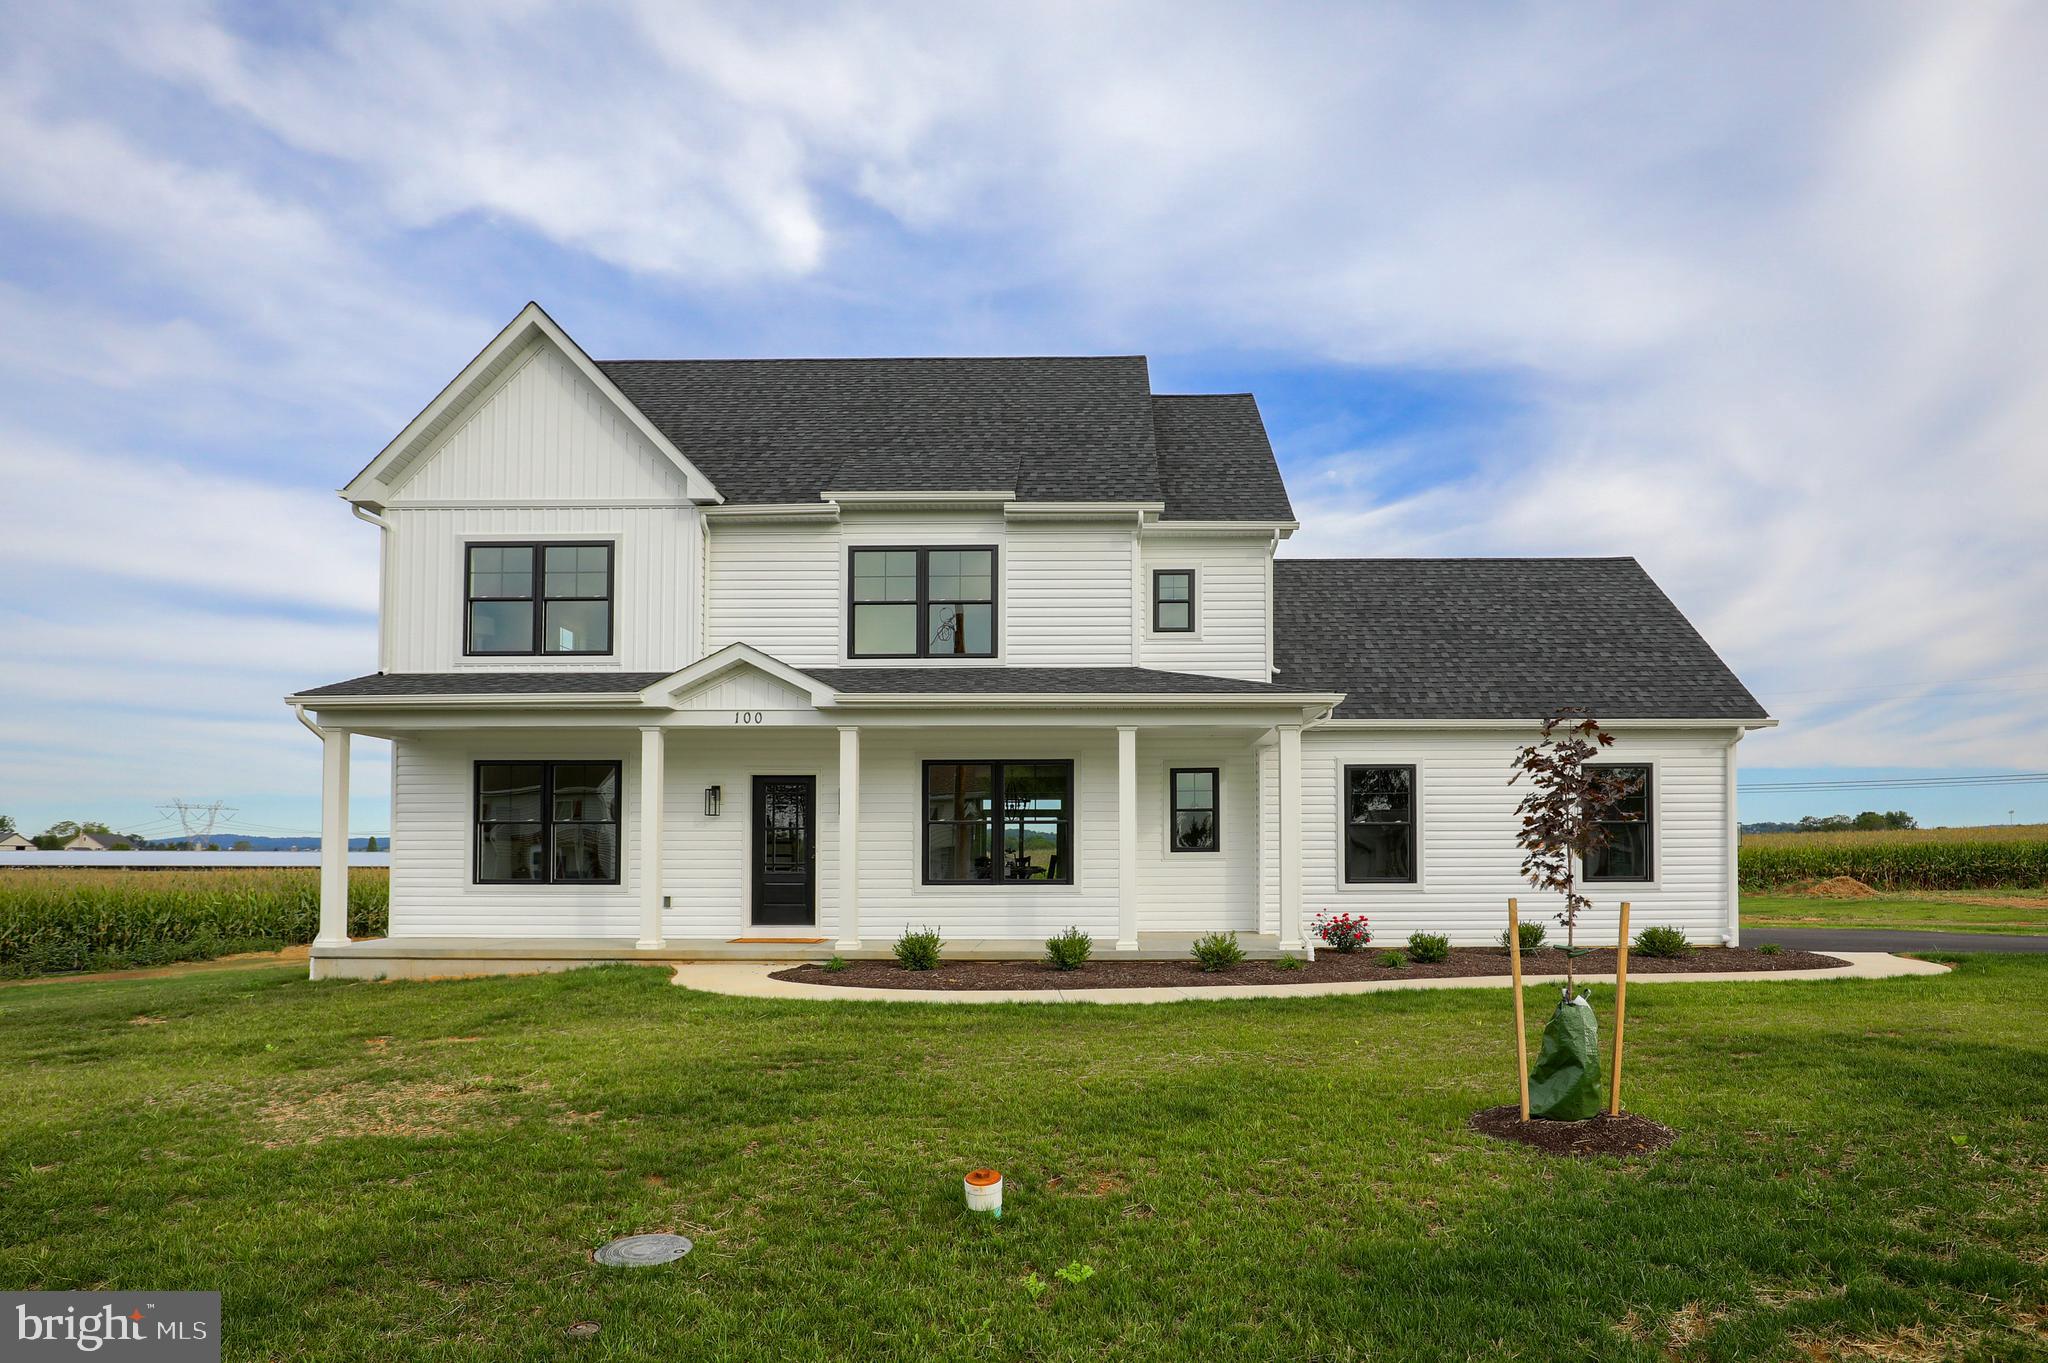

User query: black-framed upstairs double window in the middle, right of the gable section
[846,548,995,657]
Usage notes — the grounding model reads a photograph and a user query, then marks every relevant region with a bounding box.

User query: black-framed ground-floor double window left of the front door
[475,761,618,884]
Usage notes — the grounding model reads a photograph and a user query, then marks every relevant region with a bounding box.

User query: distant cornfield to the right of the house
[1739,823,2048,890]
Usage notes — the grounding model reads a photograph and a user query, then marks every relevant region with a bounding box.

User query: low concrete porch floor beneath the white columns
[311,933,1280,980]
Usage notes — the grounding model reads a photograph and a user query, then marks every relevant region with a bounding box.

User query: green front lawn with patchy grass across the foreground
[0,958,2048,1361]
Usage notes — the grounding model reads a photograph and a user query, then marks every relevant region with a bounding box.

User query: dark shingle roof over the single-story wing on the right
[1274,559,1767,720]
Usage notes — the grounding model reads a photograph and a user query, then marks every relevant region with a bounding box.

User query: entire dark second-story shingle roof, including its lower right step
[598,356,1292,520]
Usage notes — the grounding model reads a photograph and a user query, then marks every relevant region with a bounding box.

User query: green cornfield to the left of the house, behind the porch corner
[0,866,391,976]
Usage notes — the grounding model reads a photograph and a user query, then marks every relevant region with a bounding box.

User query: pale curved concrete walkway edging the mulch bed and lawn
[672,952,1948,1003]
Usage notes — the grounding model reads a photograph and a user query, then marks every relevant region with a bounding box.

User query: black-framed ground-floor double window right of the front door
[924,761,1073,884]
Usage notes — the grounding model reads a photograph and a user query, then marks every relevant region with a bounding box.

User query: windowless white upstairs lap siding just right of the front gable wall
[705,522,842,667]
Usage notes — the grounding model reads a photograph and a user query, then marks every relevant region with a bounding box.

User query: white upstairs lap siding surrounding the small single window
[1139,536,1272,682]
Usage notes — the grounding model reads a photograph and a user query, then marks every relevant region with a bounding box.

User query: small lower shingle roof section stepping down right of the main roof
[1153,393,1294,520]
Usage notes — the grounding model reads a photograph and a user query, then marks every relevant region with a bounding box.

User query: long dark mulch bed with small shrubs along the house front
[774,948,1847,991]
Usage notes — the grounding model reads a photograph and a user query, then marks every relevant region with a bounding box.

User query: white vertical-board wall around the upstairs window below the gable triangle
[383,505,702,671]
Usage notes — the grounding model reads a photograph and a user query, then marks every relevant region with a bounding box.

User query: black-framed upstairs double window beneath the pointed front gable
[465,544,612,655]
